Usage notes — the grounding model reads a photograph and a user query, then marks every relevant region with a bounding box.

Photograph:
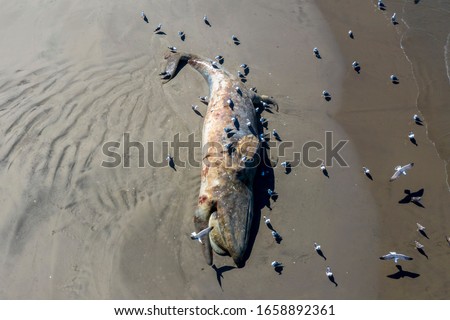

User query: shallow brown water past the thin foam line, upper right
[396,0,450,185]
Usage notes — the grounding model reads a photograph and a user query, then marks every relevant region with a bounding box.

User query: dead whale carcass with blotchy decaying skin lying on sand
[161,52,276,267]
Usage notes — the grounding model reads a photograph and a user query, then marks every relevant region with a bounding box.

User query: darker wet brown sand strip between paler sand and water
[318,1,450,299]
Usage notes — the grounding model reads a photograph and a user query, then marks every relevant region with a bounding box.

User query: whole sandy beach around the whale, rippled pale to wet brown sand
[0,0,450,299]
